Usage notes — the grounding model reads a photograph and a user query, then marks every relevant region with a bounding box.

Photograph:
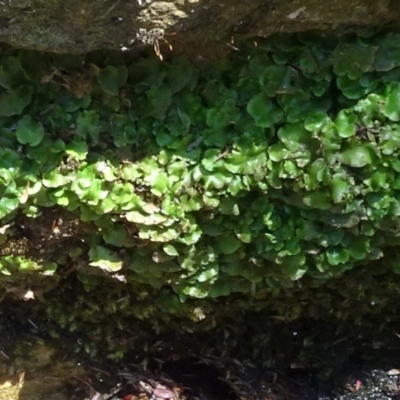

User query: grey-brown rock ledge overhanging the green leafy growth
[0,0,400,58]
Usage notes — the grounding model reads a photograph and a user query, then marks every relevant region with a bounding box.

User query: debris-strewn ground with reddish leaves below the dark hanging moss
[61,358,400,400]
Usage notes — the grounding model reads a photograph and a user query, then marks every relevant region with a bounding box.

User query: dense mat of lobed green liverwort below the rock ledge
[0,33,400,299]
